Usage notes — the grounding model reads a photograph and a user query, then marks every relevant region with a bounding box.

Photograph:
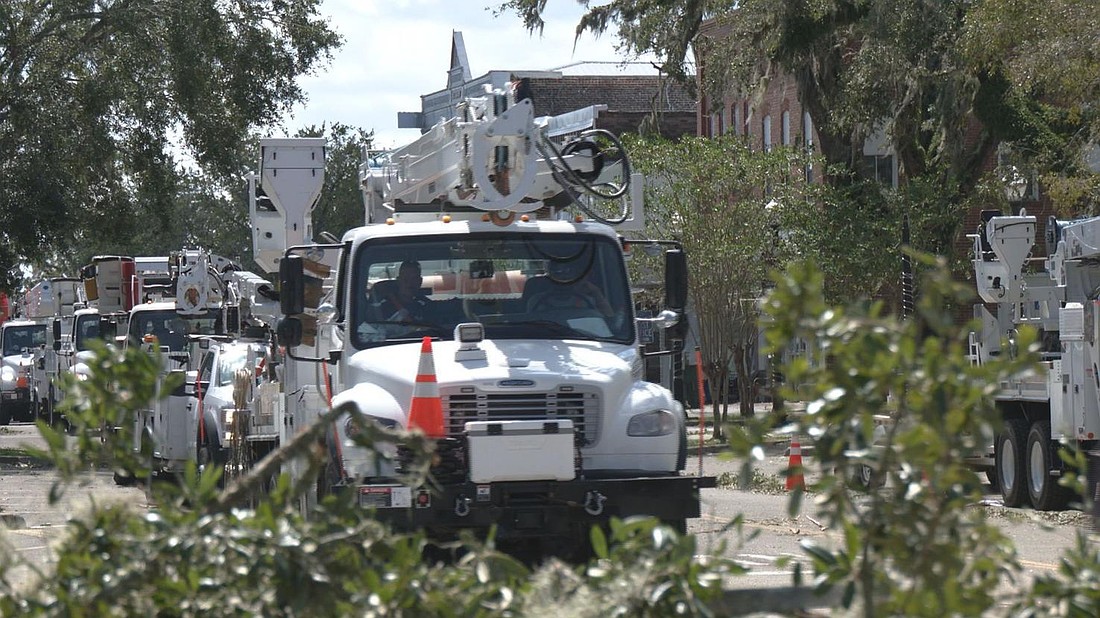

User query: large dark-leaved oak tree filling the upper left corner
[0,0,340,286]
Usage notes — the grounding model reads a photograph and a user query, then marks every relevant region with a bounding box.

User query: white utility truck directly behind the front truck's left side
[116,249,276,484]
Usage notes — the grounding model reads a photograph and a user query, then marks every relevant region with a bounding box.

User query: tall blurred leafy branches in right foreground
[732,256,1100,617]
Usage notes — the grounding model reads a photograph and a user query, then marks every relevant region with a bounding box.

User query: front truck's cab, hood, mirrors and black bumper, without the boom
[279,218,695,552]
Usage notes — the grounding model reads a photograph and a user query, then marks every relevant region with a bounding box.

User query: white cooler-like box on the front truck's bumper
[465,419,576,483]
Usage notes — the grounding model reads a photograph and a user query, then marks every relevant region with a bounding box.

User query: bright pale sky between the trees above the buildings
[285,0,651,147]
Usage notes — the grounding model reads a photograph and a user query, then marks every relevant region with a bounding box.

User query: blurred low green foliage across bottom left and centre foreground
[0,347,743,617]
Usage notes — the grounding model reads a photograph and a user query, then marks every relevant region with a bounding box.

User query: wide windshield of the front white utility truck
[350,232,635,347]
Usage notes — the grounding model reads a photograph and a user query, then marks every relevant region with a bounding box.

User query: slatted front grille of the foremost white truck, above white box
[440,386,601,445]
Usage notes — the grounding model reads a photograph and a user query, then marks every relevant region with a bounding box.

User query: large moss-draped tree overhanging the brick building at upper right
[503,0,1100,277]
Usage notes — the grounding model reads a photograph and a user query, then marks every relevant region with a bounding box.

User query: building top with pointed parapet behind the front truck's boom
[397,32,697,139]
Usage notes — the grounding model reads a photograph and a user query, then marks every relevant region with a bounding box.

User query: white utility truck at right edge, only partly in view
[970,212,1100,510]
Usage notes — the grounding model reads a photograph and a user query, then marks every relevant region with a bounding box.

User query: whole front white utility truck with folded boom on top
[237,85,714,553]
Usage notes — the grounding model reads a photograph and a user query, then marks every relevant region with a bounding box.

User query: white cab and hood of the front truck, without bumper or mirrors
[338,222,668,466]
